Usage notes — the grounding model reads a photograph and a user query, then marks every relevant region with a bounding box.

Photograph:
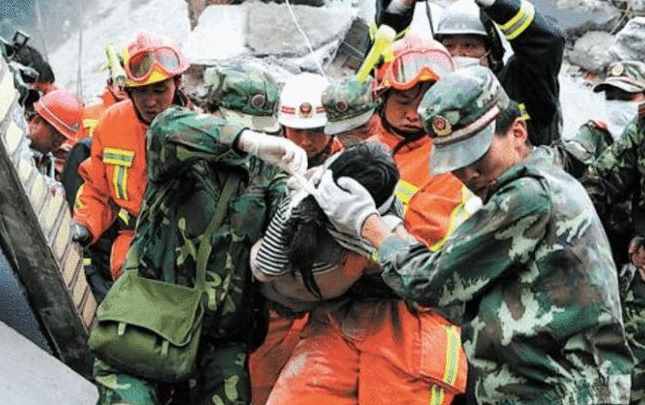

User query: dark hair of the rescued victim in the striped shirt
[284,142,399,299]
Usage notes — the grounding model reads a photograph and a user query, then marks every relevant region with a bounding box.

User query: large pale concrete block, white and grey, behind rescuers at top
[183,1,357,70]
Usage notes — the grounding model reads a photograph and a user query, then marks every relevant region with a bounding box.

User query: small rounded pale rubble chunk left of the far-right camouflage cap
[568,31,616,73]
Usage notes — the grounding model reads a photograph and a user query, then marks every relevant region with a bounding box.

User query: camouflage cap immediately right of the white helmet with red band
[322,75,379,135]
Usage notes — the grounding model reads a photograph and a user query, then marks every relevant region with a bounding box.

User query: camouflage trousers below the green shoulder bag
[94,340,251,405]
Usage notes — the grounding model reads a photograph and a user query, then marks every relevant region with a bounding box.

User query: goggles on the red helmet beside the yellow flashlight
[386,52,454,90]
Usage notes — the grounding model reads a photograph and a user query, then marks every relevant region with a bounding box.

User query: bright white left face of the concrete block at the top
[183,5,250,65]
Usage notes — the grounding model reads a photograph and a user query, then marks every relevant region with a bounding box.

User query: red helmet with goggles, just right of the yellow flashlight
[375,33,456,91]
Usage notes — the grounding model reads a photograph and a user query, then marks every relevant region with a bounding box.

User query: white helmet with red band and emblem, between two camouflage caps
[278,73,329,129]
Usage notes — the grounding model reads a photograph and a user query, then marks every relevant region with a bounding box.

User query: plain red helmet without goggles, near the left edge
[34,90,83,141]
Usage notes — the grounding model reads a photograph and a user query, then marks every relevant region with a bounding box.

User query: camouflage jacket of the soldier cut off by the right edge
[582,118,645,235]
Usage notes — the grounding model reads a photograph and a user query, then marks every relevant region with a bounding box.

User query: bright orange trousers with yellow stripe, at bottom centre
[260,300,467,405]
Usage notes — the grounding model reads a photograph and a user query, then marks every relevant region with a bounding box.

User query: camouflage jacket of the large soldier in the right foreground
[379,149,632,405]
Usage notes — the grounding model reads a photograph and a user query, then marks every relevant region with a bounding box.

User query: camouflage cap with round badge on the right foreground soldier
[418,66,510,174]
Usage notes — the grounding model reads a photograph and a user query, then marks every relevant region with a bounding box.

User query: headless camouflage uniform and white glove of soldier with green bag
[95,94,307,405]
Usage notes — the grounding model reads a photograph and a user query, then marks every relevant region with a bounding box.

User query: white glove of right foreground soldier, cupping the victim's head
[314,170,378,238]
